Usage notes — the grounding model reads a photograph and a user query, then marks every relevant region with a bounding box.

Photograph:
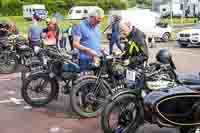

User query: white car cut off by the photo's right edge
[176,25,200,47]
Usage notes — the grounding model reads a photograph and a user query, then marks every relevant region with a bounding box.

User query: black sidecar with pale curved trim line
[144,86,200,127]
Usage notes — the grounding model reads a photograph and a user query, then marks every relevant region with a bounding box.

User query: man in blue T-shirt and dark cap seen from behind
[28,13,42,48]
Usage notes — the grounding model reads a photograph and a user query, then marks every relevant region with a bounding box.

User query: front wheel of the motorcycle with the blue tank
[21,73,59,107]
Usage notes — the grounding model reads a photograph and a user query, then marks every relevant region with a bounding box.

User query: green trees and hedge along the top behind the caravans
[0,0,152,16]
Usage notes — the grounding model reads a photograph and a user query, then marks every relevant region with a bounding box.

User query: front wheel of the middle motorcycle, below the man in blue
[70,78,112,118]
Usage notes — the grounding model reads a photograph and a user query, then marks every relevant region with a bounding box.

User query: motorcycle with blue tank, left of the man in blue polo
[21,47,91,107]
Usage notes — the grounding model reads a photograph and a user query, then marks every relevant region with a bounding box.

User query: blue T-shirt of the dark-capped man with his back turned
[28,22,42,42]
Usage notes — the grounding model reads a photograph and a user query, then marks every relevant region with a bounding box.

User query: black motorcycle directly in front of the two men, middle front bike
[70,54,125,118]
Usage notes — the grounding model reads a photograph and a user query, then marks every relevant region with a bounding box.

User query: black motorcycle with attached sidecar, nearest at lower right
[101,49,200,133]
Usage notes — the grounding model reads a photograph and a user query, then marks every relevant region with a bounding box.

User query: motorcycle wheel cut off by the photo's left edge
[0,53,17,74]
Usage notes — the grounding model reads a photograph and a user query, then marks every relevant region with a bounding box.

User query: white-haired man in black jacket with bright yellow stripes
[120,21,148,65]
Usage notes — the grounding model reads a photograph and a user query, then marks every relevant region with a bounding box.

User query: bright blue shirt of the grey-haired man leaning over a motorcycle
[72,19,101,60]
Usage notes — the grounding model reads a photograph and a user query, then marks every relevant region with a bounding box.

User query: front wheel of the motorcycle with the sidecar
[100,94,143,133]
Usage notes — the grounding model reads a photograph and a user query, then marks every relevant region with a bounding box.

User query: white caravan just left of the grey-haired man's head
[68,6,99,19]
